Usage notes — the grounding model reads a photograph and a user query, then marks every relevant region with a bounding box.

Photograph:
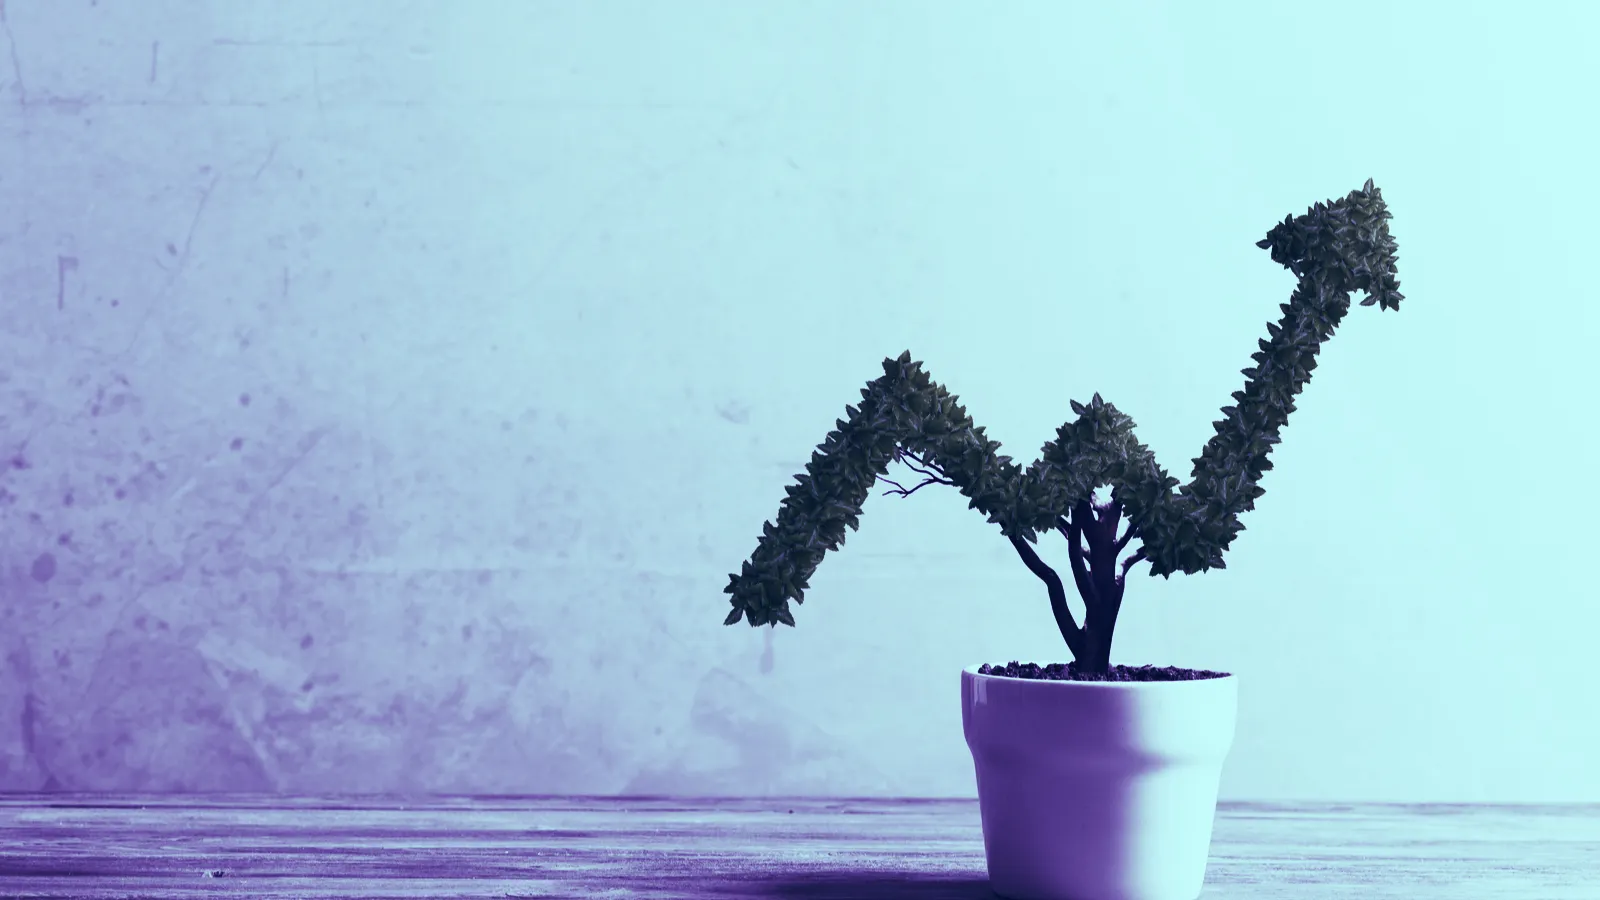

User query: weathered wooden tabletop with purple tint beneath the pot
[0,794,1600,900]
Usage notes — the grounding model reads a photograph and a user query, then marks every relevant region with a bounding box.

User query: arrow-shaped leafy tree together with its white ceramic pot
[725,179,1403,900]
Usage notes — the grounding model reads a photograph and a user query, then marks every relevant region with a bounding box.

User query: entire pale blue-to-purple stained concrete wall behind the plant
[0,0,1600,801]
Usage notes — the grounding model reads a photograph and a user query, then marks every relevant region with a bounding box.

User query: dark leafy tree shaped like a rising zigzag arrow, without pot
[723,179,1403,674]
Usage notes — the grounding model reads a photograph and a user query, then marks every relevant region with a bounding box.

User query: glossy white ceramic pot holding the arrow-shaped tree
[962,666,1238,900]
